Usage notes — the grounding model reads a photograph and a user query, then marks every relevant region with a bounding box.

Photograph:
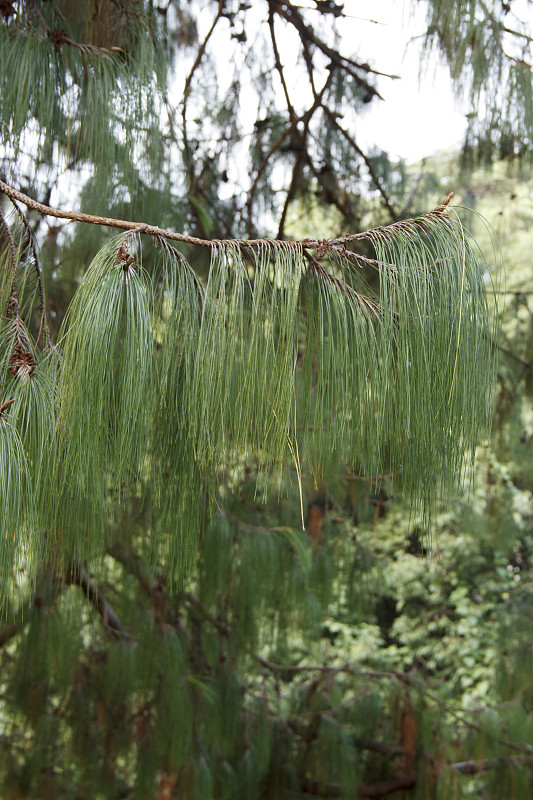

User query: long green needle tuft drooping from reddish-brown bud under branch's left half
[57,237,152,524]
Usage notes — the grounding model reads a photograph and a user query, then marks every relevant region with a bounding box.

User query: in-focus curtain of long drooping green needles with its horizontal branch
[1,184,494,599]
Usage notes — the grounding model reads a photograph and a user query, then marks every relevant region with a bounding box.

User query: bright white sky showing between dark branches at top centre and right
[190,0,467,161]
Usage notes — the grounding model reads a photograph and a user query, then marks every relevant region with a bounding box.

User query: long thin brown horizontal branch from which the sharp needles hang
[0,180,453,254]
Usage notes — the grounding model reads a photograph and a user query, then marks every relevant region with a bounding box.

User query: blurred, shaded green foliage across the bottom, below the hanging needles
[0,488,531,800]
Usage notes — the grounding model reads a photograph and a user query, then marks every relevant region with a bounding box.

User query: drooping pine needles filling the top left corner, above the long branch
[0,1,166,180]
